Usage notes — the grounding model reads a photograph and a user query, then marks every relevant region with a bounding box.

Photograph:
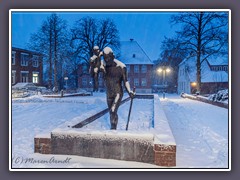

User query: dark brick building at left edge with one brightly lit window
[12,47,43,85]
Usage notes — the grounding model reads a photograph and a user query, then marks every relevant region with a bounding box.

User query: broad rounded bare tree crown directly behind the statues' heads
[71,17,120,64]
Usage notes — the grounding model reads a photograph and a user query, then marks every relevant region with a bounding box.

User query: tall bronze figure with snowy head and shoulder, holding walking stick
[103,47,135,129]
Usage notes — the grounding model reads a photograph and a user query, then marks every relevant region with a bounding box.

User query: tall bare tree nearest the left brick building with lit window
[29,13,70,92]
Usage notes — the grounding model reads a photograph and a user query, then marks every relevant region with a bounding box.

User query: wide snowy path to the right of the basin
[161,95,228,168]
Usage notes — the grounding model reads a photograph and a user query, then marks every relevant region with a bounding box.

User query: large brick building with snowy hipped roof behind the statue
[78,39,153,93]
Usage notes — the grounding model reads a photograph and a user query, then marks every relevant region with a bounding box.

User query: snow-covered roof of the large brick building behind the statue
[119,39,153,65]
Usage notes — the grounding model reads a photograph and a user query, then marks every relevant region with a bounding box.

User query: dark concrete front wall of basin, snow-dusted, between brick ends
[51,132,154,164]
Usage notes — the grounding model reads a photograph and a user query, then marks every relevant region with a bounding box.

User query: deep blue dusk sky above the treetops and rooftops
[12,11,180,61]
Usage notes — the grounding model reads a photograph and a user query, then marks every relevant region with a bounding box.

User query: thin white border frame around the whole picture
[9,9,232,171]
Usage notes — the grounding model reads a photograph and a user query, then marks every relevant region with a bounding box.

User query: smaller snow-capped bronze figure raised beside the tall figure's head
[89,46,102,92]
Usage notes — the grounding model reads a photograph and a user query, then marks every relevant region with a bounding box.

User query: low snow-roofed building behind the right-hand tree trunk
[178,56,228,94]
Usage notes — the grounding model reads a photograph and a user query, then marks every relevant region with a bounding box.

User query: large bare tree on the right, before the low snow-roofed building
[171,12,228,92]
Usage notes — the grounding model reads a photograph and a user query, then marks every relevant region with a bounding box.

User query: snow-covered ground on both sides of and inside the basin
[11,93,228,168]
